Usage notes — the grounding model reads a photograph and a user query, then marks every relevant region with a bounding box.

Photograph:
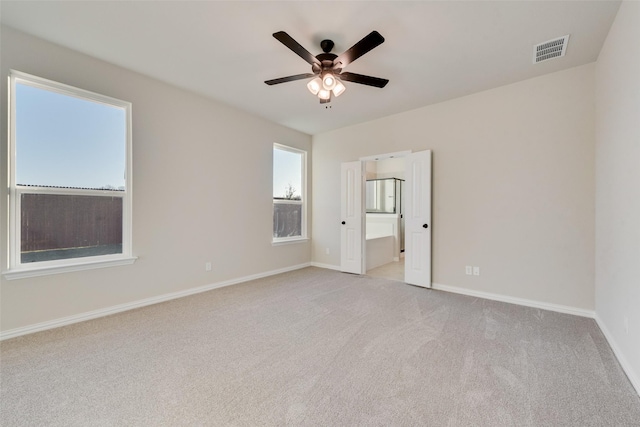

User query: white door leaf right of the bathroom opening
[404,150,431,288]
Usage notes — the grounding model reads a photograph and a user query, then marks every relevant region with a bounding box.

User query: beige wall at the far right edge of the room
[596,2,640,392]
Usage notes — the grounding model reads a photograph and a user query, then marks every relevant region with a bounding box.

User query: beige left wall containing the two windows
[0,28,311,331]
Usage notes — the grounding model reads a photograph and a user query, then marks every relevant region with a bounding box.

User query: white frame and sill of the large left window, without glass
[2,70,137,279]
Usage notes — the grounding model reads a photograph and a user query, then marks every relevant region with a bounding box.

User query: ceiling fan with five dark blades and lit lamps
[265,31,389,104]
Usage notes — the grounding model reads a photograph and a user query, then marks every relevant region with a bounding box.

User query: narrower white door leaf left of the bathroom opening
[340,161,364,274]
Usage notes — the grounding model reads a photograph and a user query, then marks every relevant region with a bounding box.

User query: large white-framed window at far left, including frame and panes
[5,71,133,278]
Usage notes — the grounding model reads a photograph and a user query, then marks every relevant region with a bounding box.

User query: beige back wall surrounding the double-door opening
[312,64,595,310]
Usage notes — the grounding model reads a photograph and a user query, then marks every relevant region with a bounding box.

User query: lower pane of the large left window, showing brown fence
[20,194,122,263]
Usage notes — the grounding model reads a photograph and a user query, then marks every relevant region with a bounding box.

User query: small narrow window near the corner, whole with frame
[273,144,307,243]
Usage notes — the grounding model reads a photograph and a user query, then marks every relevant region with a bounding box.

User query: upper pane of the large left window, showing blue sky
[15,82,126,190]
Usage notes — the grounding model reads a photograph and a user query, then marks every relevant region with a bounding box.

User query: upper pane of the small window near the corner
[273,148,302,200]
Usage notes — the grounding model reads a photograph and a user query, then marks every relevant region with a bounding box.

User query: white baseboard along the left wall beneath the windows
[0,263,311,341]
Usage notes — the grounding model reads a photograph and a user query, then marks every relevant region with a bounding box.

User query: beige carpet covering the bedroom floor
[0,268,640,426]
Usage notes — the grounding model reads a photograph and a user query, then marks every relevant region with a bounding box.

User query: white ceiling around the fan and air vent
[0,0,620,135]
